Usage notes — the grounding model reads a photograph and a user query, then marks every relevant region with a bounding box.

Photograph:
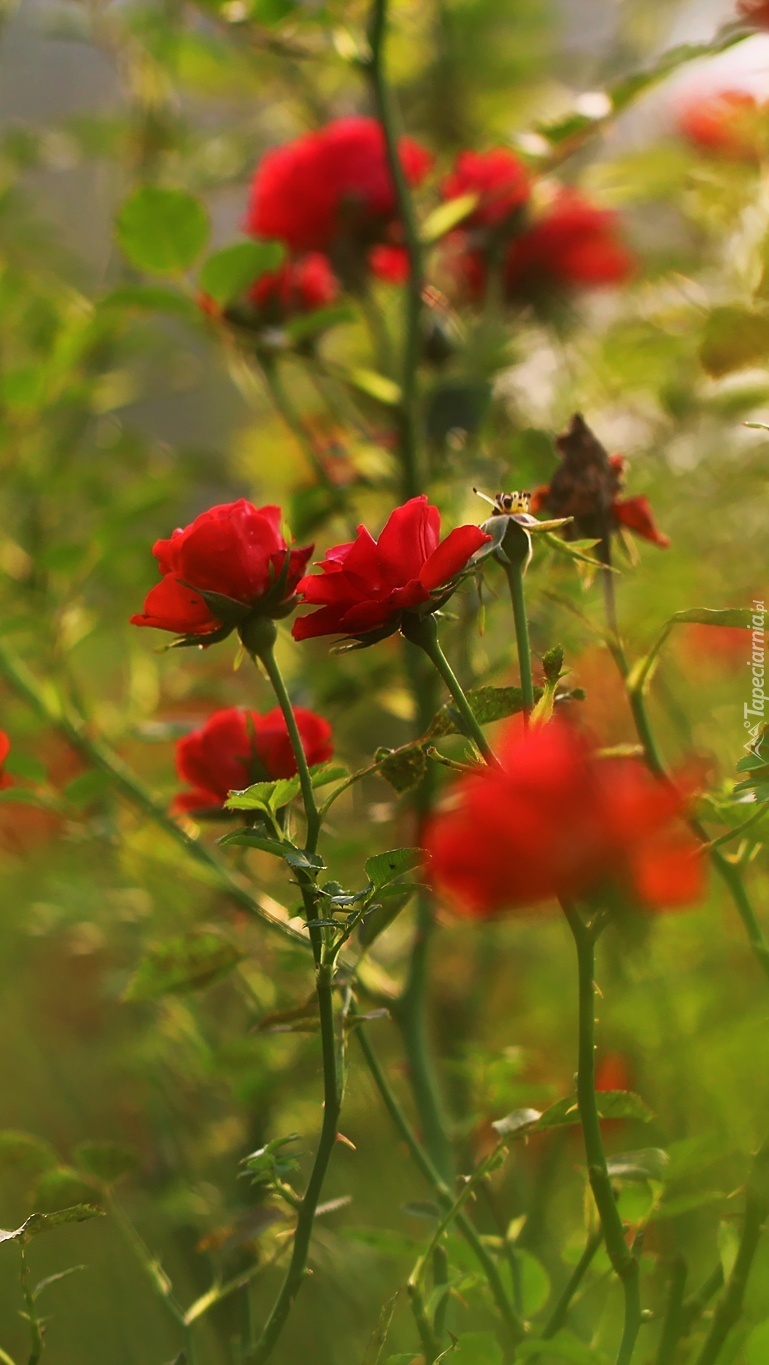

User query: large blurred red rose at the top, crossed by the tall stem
[246,117,432,251]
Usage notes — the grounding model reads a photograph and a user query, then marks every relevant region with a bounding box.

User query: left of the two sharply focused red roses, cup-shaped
[131,498,313,639]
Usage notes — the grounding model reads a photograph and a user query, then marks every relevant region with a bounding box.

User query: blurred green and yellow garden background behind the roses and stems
[0,0,769,1365]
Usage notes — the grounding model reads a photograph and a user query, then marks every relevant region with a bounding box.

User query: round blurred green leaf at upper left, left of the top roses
[117,184,209,274]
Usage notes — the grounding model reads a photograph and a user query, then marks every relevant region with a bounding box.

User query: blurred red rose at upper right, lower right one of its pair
[453,190,634,303]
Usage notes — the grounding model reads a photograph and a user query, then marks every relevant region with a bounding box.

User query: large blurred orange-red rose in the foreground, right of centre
[425,721,702,919]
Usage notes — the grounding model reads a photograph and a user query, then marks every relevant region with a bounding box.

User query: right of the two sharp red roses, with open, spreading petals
[292,494,490,640]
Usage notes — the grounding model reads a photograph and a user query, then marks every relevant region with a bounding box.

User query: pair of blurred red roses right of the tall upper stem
[441,149,634,303]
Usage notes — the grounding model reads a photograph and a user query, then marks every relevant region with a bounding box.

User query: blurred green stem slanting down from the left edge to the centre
[0,642,305,942]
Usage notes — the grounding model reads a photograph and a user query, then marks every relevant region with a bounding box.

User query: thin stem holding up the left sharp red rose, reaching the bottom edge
[243,644,343,1365]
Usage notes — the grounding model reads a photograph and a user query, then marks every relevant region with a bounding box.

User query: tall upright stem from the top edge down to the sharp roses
[365,0,425,498]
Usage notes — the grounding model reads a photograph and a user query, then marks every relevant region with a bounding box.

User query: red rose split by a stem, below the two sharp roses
[173,706,333,811]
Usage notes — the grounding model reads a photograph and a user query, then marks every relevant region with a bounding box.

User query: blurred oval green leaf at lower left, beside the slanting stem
[123,930,243,1001]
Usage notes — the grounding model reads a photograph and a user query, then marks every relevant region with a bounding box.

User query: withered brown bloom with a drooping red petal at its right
[531,412,671,549]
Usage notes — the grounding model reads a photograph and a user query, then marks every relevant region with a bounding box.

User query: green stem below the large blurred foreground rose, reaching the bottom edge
[561,901,641,1365]
